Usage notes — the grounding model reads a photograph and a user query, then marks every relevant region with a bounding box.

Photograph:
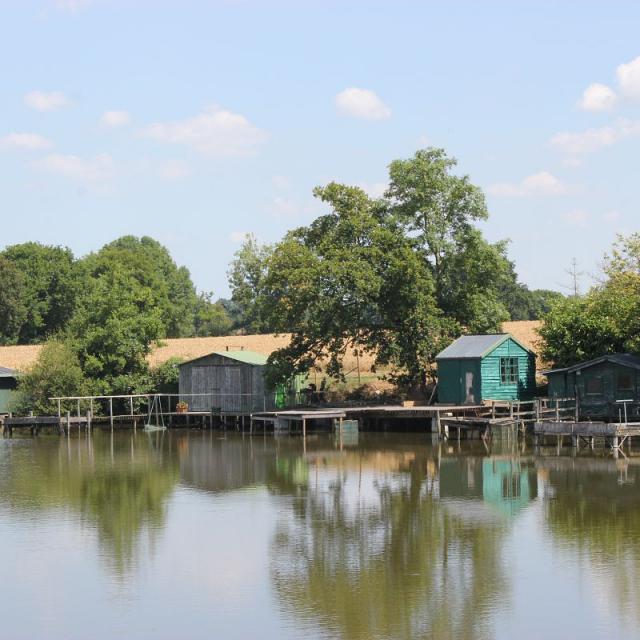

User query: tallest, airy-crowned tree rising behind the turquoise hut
[385,148,510,332]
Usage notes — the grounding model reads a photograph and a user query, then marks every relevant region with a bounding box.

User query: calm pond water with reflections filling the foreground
[0,431,640,640]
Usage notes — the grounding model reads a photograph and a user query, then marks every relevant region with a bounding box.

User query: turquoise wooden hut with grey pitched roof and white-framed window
[436,333,536,404]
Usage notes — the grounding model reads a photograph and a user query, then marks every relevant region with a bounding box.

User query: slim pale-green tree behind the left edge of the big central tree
[227,234,274,333]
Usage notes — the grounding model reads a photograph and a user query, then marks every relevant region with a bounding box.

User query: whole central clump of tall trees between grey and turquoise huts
[252,149,516,388]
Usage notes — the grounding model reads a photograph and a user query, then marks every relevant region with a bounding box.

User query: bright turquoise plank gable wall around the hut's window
[480,338,536,400]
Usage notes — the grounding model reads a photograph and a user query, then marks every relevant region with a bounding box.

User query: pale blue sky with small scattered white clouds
[0,0,640,296]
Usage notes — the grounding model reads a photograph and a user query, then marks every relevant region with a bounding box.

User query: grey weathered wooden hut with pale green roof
[179,351,275,415]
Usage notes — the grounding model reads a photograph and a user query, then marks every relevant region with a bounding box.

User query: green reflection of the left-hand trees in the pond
[0,432,179,576]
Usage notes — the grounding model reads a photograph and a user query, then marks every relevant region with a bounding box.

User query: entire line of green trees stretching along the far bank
[13,148,620,410]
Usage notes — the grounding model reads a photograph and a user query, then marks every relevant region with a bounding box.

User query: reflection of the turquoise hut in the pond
[439,457,538,519]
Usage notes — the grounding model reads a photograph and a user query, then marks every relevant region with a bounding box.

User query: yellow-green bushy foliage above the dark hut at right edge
[540,234,640,366]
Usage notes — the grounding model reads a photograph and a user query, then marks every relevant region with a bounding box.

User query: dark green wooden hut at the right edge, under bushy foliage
[543,353,640,420]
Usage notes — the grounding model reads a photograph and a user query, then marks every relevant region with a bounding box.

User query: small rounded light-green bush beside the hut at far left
[12,340,86,415]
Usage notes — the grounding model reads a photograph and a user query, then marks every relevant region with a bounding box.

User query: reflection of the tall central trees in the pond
[271,448,528,639]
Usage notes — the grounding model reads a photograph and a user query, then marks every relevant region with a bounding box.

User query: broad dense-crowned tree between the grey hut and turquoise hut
[259,183,452,384]
